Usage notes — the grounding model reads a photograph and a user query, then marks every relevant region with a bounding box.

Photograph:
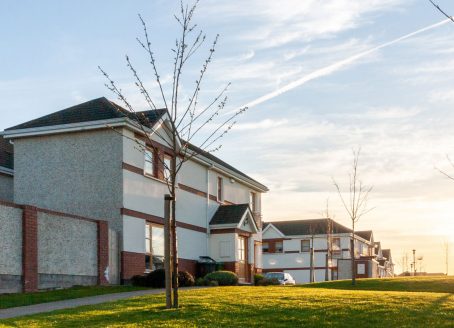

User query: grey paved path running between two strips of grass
[0,287,203,319]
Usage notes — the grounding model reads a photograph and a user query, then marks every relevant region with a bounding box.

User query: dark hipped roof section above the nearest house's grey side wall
[5,97,167,131]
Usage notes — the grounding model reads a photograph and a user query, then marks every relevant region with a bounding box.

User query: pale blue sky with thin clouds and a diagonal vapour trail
[0,0,454,274]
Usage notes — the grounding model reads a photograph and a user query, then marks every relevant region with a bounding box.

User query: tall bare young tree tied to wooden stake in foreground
[99,0,247,307]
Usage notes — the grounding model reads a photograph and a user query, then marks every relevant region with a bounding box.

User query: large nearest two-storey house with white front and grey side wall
[0,98,268,290]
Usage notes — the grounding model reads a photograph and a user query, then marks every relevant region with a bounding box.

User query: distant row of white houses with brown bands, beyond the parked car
[262,218,391,283]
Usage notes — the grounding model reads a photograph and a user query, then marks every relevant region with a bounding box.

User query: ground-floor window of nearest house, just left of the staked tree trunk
[145,223,164,270]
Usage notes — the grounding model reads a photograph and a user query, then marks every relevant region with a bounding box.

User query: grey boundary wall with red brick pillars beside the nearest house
[0,201,109,293]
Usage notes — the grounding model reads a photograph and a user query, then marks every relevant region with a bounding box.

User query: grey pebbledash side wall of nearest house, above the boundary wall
[14,129,123,231]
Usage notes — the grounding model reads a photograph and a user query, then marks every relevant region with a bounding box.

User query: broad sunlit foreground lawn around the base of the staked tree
[0,278,454,328]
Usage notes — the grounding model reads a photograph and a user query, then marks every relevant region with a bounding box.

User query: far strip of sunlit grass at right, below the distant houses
[301,276,454,293]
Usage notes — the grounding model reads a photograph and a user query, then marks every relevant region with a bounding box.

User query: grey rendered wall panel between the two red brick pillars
[38,212,98,289]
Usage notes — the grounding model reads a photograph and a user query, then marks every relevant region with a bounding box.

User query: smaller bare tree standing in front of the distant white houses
[333,148,373,285]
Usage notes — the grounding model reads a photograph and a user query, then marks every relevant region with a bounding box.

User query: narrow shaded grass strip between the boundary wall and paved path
[0,286,143,309]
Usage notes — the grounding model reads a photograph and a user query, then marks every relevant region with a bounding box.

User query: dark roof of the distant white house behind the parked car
[263,219,351,236]
